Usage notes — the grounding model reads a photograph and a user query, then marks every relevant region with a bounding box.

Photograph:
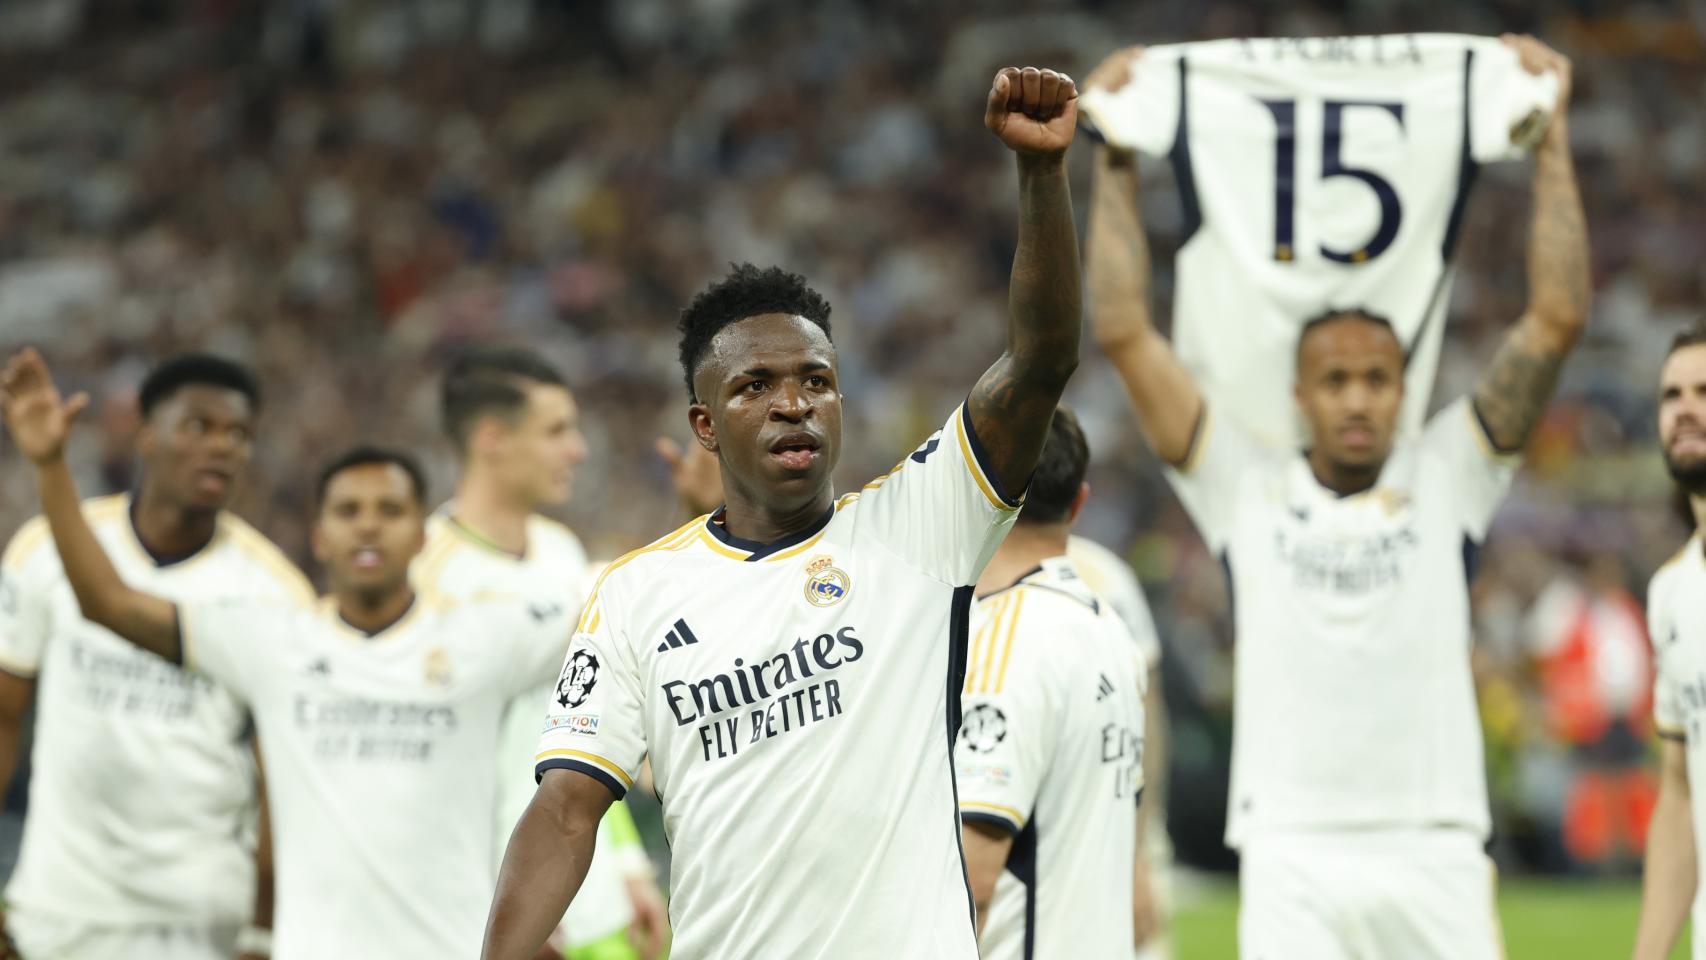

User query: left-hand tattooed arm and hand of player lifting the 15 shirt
[1085,48,1203,466]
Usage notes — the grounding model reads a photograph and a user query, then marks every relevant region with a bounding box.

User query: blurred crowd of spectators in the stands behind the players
[0,0,1706,871]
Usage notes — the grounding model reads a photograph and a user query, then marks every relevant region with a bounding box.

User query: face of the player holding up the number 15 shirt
[1297,317,1404,469]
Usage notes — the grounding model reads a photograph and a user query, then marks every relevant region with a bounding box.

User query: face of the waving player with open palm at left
[314,464,427,595]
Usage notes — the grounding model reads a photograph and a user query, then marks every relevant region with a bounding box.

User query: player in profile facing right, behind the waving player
[413,346,669,960]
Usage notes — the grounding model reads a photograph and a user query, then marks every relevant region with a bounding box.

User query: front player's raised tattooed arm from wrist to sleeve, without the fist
[967,157,1083,491]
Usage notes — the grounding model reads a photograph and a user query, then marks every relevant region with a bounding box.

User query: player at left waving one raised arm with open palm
[0,350,573,960]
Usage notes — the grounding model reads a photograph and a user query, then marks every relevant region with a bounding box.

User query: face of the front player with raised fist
[688,314,841,512]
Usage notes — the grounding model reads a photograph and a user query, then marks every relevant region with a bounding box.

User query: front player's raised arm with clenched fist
[967,67,1082,491]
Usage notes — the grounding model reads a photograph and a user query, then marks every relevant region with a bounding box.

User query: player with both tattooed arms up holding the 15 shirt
[1088,38,1592,960]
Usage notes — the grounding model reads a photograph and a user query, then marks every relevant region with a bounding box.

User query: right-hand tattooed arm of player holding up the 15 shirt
[1474,36,1593,452]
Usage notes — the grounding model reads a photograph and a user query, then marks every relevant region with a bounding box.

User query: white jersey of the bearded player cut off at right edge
[1646,532,1706,957]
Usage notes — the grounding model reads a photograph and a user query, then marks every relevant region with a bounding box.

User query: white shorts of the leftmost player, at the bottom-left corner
[5,909,237,960]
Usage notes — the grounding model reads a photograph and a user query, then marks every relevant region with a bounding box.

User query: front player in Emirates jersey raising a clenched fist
[485,68,1080,960]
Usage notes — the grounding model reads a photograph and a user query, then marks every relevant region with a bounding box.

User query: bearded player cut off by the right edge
[1634,321,1706,960]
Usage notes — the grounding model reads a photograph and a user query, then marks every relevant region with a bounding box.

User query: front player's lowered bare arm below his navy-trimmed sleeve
[479,771,616,960]
